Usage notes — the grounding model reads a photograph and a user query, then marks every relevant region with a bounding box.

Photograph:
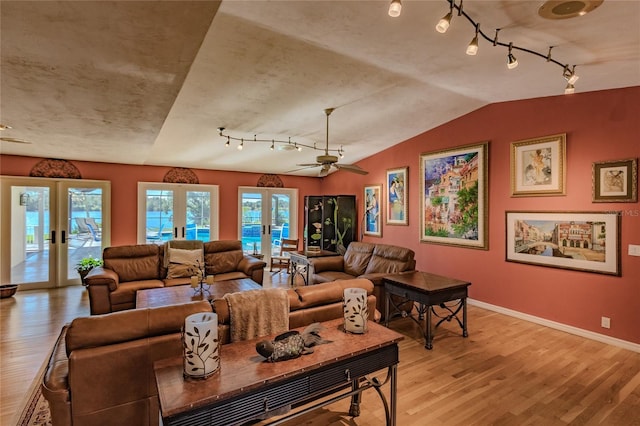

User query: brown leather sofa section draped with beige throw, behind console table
[211,279,380,343]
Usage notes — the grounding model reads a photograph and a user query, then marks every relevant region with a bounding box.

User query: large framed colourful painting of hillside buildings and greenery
[420,142,489,250]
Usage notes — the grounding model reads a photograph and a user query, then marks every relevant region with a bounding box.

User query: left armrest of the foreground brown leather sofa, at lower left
[40,324,71,425]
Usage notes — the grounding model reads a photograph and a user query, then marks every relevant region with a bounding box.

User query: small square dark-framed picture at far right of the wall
[591,158,638,203]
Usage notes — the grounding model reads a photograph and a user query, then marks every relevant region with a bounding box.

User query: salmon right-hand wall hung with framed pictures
[323,87,640,343]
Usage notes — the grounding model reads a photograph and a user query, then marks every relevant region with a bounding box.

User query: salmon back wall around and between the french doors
[0,155,321,247]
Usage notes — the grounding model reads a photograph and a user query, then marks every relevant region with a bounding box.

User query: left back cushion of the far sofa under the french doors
[102,244,161,282]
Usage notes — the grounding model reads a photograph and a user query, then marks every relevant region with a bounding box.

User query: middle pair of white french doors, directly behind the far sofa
[138,182,219,244]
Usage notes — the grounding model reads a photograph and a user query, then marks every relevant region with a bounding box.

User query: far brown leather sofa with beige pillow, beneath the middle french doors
[85,240,266,315]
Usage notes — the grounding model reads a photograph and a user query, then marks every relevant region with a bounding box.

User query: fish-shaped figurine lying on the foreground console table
[256,322,331,362]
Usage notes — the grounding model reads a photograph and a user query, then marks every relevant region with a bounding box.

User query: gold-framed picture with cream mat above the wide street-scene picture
[511,134,567,197]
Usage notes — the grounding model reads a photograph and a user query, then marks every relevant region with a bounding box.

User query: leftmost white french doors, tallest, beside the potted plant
[0,176,111,290]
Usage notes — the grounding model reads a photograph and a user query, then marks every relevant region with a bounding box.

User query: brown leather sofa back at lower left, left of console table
[41,301,211,426]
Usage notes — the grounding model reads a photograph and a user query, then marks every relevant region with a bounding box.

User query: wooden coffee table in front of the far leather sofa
[136,278,262,308]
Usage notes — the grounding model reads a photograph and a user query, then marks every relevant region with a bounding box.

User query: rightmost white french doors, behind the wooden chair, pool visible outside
[238,187,298,263]
